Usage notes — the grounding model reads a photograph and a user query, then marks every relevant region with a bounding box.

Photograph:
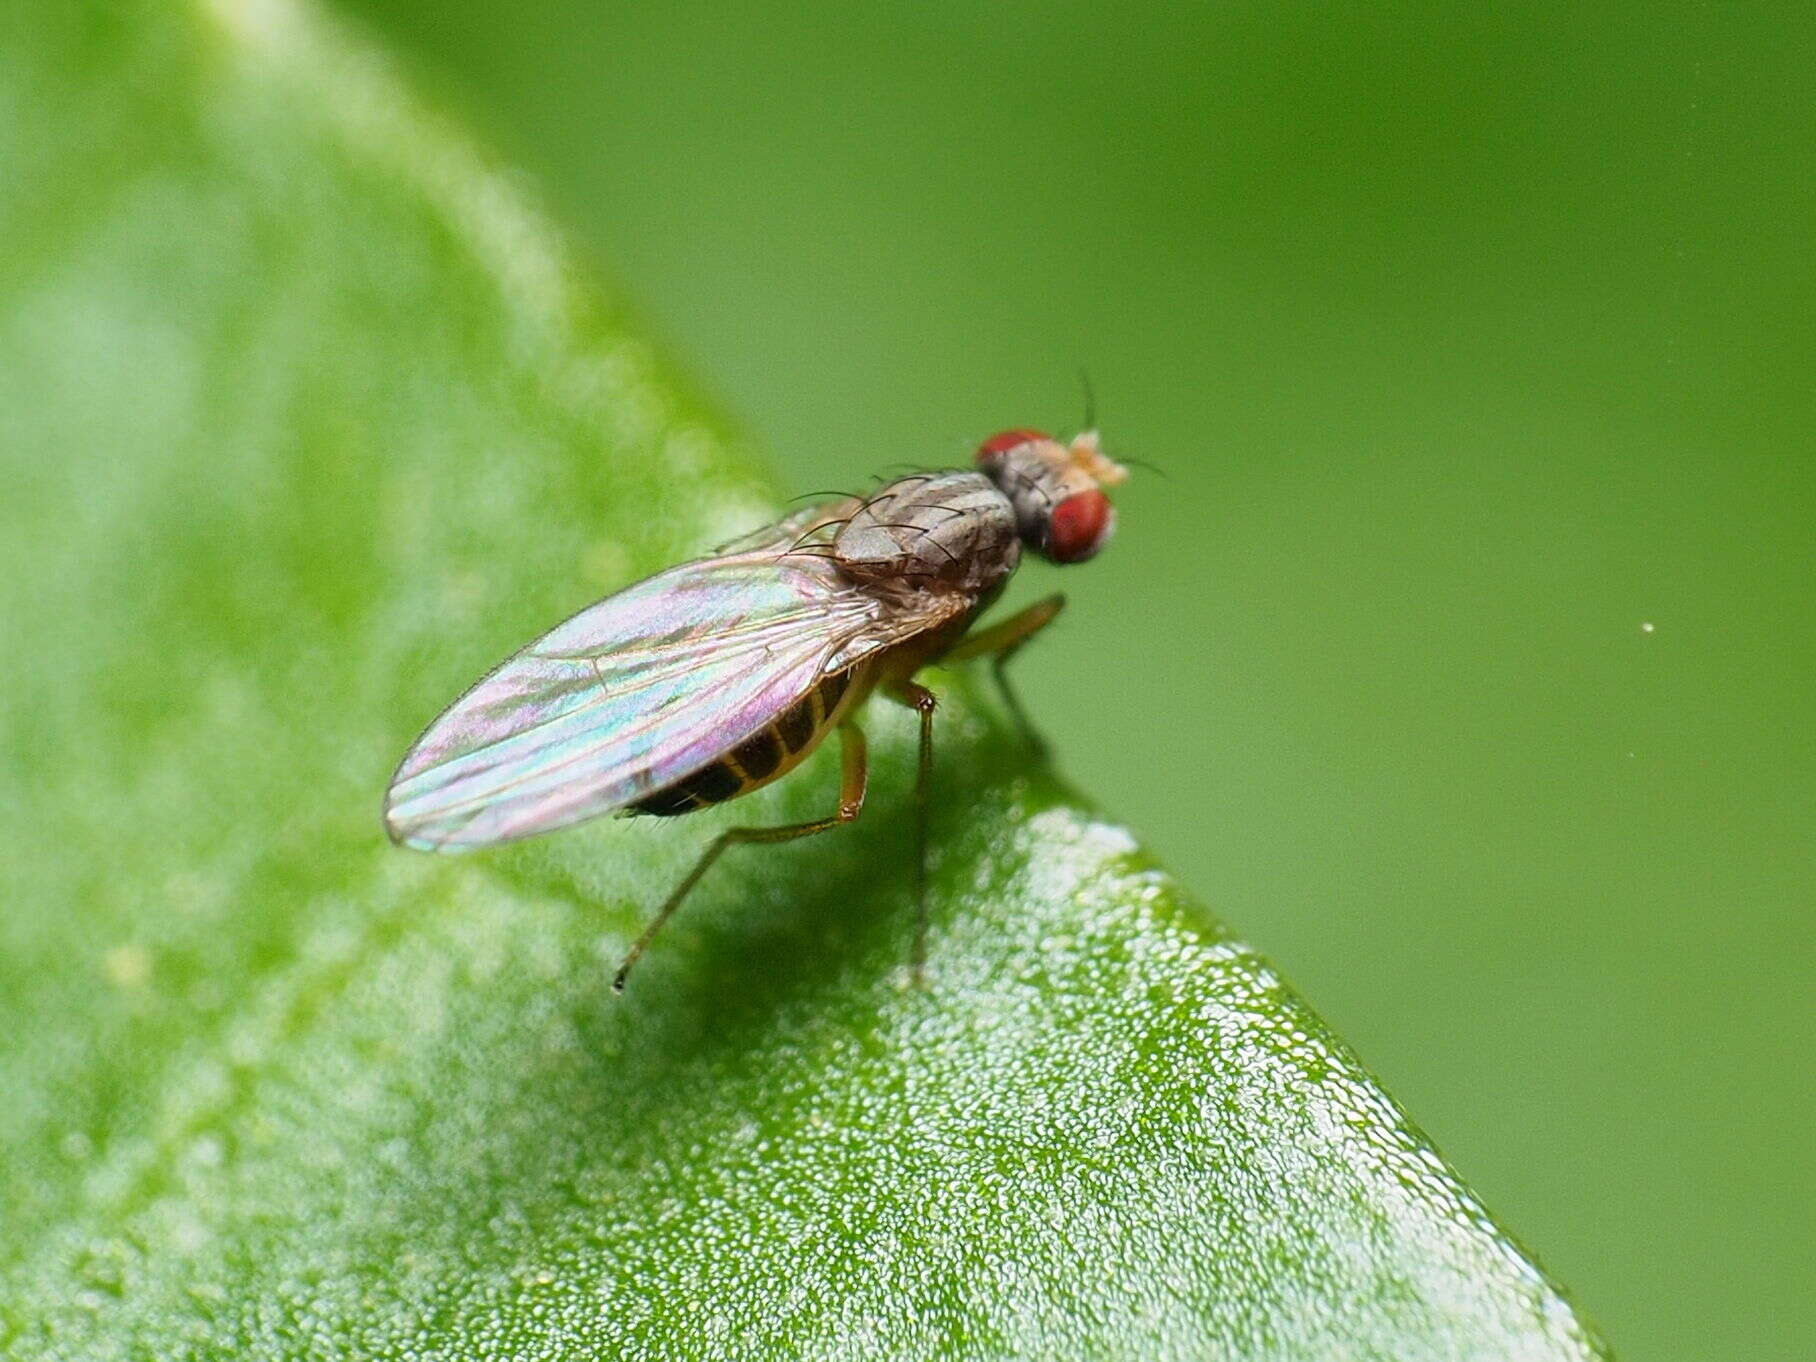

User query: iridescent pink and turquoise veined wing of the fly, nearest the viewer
[385,548,952,850]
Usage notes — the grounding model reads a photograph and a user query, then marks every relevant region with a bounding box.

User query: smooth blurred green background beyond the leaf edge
[341,0,1816,1358]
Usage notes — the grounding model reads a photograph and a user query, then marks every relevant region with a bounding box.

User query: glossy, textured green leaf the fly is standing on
[0,0,1598,1358]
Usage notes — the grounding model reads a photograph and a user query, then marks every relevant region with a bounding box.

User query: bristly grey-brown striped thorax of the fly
[832,470,1021,592]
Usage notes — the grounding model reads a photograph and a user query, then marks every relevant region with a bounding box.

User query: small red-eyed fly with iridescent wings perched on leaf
[385,430,1126,992]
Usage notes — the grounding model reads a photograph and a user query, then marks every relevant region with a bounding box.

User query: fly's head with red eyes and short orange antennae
[977,430,1128,563]
